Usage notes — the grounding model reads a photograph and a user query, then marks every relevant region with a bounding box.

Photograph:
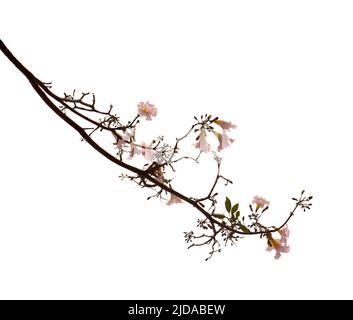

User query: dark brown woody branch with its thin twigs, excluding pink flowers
[0,40,311,256]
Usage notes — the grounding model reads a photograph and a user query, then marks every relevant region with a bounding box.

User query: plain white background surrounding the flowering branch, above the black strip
[0,0,353,299]
